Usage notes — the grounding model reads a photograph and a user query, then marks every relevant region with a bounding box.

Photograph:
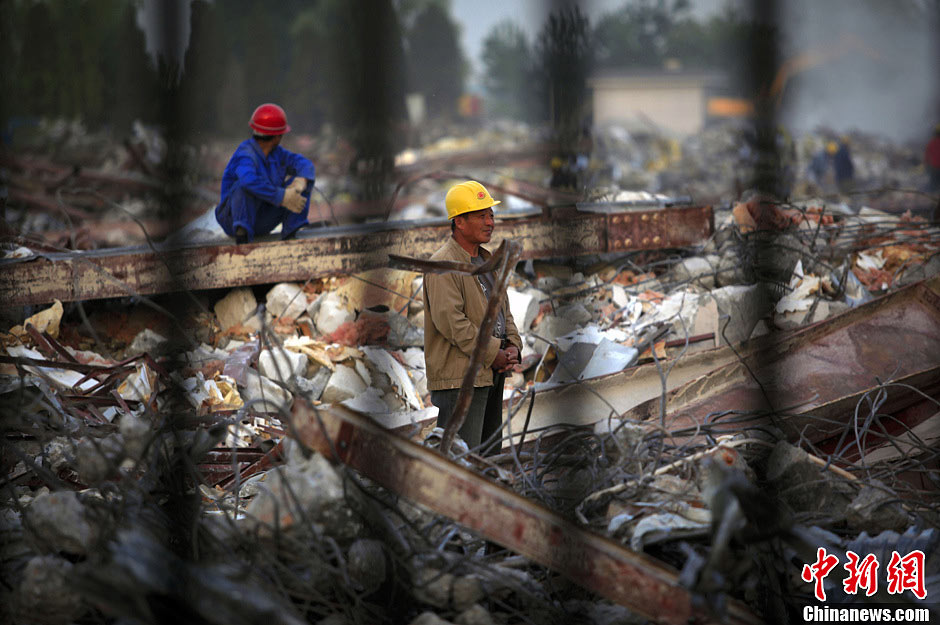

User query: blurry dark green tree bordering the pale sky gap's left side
[408,3,466,117]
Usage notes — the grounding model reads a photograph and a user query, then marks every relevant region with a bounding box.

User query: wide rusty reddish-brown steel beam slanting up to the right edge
[622,278,940,442]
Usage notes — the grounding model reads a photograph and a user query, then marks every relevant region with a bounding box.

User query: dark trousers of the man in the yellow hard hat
[431,373,506,455]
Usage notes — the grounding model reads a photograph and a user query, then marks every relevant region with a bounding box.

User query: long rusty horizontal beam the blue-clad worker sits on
[0,206,713,306]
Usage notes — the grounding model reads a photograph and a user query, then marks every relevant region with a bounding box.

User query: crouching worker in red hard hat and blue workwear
[215,104,316,243]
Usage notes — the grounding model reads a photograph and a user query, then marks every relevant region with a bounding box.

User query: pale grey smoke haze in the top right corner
[780,0,940,141]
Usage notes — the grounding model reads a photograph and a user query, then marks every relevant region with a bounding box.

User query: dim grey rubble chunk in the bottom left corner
[14,555,84,625]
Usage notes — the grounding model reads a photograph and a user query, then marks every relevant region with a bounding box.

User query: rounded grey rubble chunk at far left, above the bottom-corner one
[23,491,96,555]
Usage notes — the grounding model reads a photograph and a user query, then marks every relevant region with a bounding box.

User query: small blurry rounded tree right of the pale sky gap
[483,20,533,120]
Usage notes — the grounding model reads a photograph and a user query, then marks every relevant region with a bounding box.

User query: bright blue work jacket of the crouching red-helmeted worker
[220,139,316,206]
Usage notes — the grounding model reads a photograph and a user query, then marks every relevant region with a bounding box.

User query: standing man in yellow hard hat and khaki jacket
[424,180,522,453]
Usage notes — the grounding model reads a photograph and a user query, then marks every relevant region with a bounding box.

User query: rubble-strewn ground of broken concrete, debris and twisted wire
[0,118,940,625]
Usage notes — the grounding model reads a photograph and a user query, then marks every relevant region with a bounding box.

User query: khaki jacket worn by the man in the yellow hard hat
[423,237,522,391]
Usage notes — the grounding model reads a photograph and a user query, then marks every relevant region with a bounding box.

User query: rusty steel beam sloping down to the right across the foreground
[290,401,760,625]
